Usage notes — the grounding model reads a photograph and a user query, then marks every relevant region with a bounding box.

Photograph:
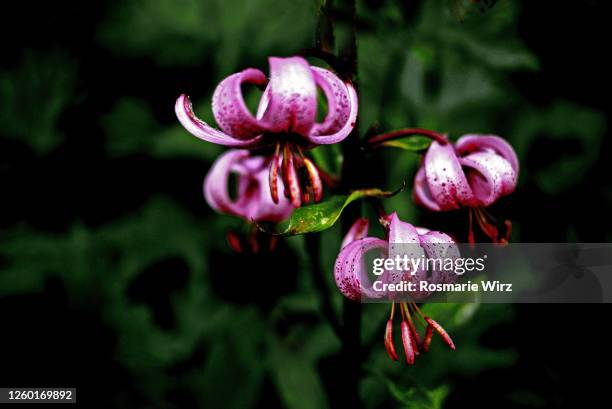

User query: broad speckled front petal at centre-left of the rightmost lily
[425,141,474,210]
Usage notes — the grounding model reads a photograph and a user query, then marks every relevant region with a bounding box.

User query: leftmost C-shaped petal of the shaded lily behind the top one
[204,150,249,217]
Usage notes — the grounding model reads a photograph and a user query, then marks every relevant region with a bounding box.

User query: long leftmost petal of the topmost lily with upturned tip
[174,94,264,148]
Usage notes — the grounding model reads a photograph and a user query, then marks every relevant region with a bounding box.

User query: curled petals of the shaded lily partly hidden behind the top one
[204,149,293,223]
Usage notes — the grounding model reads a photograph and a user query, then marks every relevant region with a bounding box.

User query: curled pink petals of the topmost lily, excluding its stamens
[175,57,357,149]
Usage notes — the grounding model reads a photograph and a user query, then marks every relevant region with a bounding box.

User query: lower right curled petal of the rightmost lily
[460,152,516,206]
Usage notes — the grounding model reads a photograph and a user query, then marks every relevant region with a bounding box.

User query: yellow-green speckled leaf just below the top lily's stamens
[272,189,397,236]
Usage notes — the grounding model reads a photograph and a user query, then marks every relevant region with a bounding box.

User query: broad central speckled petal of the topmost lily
[263,57,317,136]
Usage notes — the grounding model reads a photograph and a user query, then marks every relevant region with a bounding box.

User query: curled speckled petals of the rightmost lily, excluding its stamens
[413,135,519,211]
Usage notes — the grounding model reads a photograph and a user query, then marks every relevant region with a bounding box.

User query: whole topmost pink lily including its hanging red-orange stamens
[175,57,357,207]
